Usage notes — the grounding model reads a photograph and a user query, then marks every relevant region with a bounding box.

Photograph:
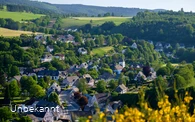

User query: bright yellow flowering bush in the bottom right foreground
[89,92,195,122]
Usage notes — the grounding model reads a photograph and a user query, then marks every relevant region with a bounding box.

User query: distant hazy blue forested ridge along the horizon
[0,0,164,16]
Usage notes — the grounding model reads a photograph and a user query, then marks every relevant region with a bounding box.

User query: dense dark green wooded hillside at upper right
[82,10,195,44]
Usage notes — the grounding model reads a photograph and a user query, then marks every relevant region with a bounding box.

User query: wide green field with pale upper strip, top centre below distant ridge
[62,17,130,28]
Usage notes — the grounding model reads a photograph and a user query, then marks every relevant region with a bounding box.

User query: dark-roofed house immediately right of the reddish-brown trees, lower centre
[88,93,111,111]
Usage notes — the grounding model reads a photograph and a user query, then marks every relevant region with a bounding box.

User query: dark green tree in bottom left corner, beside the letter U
[0,107,12,121]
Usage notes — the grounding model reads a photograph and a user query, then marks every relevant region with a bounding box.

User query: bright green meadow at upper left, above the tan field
[0,11,44,21]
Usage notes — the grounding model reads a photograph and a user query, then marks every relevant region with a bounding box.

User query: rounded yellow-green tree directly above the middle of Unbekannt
[30,84,45,98]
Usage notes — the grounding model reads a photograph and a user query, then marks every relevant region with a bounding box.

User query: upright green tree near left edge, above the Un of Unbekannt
[9,80,20,98]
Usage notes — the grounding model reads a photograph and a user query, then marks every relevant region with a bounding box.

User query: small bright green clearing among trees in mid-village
[91,46,113,56]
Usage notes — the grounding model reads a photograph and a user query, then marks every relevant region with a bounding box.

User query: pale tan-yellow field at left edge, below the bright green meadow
[0,28,40,37]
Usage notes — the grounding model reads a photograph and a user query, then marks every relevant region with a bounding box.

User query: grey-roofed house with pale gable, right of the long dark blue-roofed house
[61,76,79,87]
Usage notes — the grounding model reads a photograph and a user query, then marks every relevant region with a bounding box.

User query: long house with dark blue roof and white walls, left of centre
[37,70,59,80]
